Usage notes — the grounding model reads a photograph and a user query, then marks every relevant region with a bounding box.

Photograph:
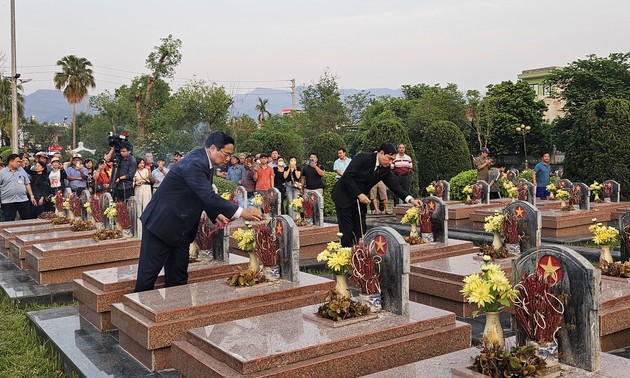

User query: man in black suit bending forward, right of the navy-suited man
[332,143,420,247]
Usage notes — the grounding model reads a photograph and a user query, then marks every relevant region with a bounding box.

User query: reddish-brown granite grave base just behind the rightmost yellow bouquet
[540,209,610,238]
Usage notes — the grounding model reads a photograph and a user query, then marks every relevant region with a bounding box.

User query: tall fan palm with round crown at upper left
[53,55,96,148]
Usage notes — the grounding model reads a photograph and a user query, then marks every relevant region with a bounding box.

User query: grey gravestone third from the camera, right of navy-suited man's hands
[271,215,300,283]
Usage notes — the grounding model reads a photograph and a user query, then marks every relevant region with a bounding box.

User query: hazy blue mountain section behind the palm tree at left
[24,89,97,123]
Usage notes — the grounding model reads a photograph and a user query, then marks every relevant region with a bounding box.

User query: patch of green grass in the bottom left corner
[0,297,65,378]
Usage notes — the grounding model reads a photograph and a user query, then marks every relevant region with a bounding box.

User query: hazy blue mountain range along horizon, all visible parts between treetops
[24,87,403,123]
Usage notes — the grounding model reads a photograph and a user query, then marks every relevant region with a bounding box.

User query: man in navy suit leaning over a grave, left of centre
[135,132,262,292]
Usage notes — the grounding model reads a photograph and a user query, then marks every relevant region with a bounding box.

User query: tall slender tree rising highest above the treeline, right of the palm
[135,34,182,147]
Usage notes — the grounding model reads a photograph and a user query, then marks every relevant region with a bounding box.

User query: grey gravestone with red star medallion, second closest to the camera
[364,227,410,315]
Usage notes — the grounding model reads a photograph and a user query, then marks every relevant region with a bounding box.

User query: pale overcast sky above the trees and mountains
[0,0,630,94]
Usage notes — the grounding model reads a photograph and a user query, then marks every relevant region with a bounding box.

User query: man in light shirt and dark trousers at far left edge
[0,154,35,221]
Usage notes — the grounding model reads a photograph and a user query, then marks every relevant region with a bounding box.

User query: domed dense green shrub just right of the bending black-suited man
[417,121,470,192]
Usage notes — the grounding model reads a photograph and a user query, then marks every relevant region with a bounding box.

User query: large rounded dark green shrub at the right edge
[564,98,630,200]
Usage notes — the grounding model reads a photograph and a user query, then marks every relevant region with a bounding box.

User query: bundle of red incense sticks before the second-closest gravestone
[352,239,382,312]
